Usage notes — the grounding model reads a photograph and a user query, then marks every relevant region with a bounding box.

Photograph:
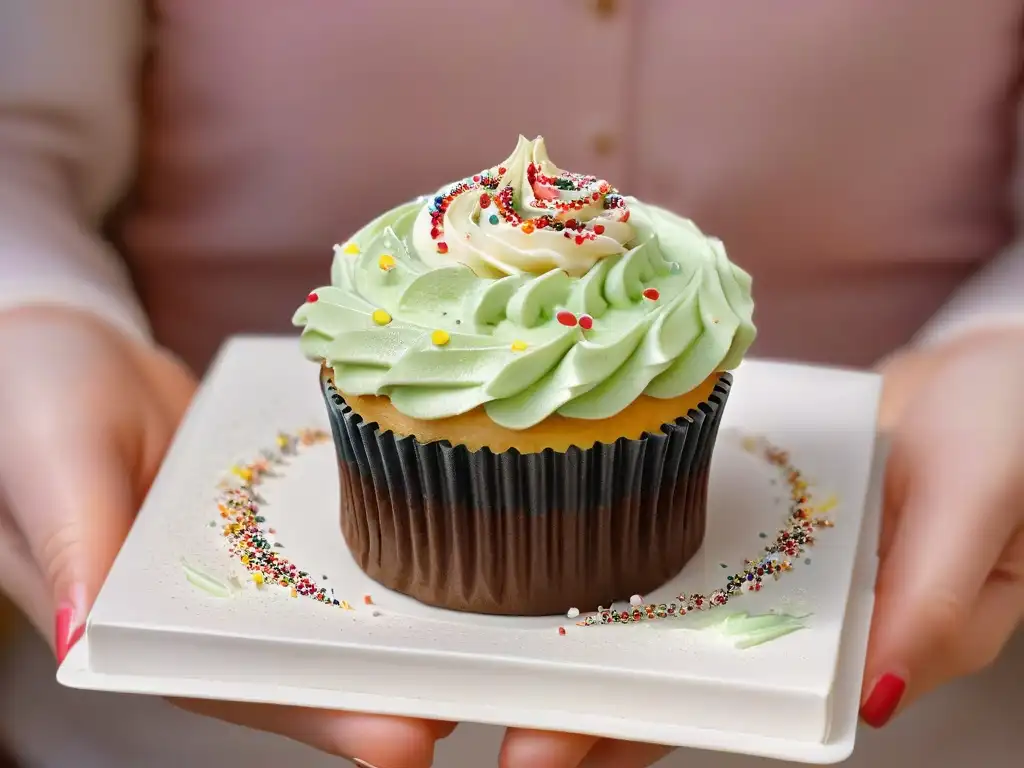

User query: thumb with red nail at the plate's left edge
[0,416,134,659]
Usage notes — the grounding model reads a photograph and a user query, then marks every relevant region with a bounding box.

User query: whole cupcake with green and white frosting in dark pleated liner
[294,137,755,615]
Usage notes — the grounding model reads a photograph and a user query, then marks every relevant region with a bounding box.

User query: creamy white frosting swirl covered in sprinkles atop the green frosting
[413,136,635,278]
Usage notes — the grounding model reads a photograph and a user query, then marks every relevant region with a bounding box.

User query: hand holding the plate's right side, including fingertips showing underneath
[500,328,1024,768]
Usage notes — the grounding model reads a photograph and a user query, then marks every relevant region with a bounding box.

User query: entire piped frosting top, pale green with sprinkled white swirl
[294,137,756,429]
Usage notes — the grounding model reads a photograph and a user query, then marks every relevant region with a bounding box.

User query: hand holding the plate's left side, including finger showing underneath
[0,307,455,768]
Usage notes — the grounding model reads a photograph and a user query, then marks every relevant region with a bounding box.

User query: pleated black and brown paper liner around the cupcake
[322,374,732,615]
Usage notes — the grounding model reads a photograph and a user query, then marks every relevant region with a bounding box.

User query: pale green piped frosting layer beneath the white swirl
[294,138,756,429]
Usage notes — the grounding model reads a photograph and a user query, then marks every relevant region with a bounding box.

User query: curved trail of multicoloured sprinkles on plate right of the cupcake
[577,439,835,626]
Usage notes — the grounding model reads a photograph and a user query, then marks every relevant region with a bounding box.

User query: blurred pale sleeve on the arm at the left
[0,0,148,336]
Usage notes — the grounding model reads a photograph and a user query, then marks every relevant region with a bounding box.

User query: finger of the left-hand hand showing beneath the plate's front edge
[175,699,455,768]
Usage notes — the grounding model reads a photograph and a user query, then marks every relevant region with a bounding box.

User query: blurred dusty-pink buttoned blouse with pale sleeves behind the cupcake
[0,0,1024,368]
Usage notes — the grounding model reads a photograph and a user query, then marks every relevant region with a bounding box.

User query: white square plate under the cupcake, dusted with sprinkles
[58,338,882,763]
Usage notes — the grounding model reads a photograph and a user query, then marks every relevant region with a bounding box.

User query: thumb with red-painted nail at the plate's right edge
[861,433,1014,727]
